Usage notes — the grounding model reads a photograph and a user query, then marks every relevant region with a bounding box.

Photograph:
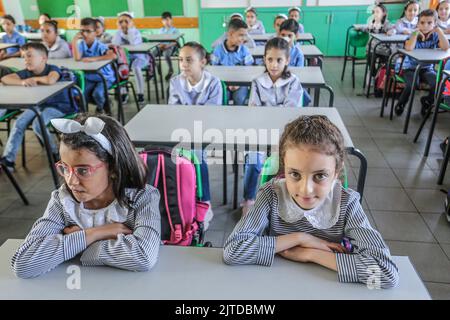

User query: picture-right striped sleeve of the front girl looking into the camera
[336,192,399,289]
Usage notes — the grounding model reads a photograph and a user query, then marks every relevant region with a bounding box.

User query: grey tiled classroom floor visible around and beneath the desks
[0,59,450,299]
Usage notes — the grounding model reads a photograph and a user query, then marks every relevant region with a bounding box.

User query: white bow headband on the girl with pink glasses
[51,117,112,155]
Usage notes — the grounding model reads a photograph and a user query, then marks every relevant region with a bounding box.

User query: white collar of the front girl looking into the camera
[273,179,342,229]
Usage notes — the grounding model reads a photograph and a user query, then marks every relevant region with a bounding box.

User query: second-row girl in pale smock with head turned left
[169,42,223,230]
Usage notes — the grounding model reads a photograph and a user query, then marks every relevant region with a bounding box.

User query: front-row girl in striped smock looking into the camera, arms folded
[223,115,399,289]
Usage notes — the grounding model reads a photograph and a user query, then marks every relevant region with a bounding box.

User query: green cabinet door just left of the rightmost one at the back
[303,11,331,55]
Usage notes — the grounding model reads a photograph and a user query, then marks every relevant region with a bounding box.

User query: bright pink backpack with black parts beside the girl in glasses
[140,146,209,246]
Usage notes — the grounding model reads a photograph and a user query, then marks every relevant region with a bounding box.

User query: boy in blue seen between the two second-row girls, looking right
[211,19,253,105]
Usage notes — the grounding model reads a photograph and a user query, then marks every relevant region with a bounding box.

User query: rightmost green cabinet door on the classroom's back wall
[327,10,358,56]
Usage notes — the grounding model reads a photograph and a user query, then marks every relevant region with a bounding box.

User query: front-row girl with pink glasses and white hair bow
[11,115,161,278]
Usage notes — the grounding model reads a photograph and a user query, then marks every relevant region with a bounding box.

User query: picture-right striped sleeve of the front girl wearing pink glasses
[80,185,161,271]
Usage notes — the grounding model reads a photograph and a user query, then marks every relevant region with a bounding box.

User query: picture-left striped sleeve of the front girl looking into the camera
[223,184,276,266]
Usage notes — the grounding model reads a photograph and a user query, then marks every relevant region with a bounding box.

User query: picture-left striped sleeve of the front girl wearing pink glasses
[11,191,86,278]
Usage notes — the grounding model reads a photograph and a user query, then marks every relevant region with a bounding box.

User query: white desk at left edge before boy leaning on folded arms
[0,81,74,187]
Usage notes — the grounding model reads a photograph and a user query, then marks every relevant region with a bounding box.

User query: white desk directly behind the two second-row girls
[206,66,334,107]
